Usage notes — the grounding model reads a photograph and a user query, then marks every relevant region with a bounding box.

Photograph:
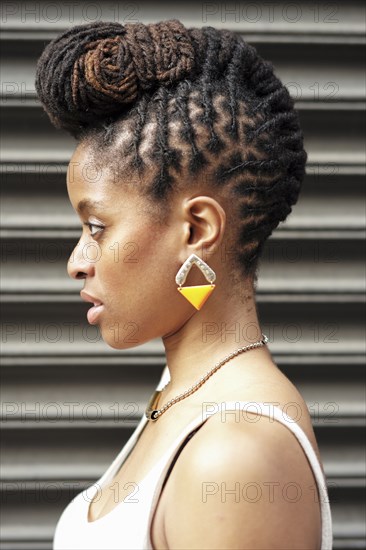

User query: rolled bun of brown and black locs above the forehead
[35,19,195,132]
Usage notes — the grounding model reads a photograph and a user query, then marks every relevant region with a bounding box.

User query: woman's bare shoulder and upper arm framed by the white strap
[164,412,320,550]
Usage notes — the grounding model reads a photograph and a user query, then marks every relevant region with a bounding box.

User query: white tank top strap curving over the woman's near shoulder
[145,401,333,550]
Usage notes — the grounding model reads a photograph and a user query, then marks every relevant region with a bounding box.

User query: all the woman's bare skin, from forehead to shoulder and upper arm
[67,144,320,550]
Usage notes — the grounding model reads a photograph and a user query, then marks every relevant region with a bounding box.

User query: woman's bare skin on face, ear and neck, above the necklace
[67,140,268,395]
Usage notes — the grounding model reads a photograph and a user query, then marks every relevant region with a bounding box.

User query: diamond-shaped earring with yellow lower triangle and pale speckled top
[175,254,216,309]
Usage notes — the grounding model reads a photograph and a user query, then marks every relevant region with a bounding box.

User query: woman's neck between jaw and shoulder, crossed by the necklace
[163,284,271,402]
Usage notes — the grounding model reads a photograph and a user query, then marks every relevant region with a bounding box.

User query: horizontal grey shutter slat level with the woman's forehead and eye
[1,172,366,233]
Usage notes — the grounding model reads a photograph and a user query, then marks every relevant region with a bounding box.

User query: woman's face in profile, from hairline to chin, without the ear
[67,144,192,349]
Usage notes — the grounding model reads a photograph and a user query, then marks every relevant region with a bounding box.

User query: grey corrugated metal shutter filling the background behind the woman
[1,1,365,550]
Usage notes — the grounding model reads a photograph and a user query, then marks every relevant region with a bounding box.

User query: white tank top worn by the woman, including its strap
[53,367,333,550]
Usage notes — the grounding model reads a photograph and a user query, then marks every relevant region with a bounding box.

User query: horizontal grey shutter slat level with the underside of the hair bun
[1,107,365,165]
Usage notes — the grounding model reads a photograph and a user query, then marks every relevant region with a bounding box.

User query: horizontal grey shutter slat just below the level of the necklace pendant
[1,424,366,480]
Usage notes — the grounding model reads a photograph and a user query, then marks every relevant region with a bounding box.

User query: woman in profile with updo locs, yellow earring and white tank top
[36,19,332,550]
